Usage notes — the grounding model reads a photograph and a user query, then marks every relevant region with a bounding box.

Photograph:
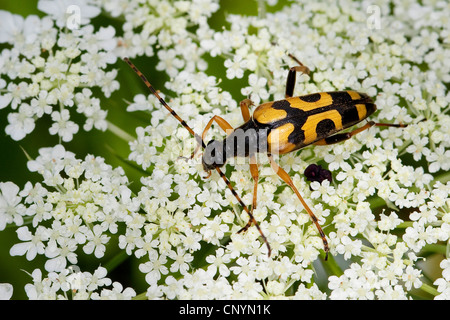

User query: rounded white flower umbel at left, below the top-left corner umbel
[7,145,134,272]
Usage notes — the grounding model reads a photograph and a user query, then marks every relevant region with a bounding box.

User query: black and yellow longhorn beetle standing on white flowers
[124,54,407,260]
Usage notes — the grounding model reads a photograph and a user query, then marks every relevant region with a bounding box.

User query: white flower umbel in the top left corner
[0,8,114,142]
